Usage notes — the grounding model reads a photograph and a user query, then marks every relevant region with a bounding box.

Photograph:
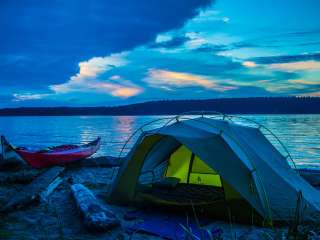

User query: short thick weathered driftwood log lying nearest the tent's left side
[71,184,120,231]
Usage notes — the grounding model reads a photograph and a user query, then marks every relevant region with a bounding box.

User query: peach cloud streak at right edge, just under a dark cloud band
[268,60,320,72]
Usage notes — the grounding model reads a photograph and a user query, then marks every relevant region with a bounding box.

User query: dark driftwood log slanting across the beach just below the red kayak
[0,167,64,212]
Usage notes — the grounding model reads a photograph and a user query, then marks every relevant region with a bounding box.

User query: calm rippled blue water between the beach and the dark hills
[0,115,320,167]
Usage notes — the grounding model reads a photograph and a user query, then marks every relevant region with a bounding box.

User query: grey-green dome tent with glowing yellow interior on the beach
[109,117,320,221]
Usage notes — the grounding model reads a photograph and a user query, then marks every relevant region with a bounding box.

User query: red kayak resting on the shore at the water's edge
[2,137,101,168]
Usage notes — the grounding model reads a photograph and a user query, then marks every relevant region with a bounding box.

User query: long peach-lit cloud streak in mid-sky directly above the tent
[144,69,236,92]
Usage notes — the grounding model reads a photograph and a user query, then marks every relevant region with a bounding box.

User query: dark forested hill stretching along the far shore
[0,97,320,116]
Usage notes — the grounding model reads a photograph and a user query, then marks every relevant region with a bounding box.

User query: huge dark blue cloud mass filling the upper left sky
[0,0,211,95]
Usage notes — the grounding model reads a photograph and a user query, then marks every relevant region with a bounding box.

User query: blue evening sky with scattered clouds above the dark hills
[0,0,320,108]
